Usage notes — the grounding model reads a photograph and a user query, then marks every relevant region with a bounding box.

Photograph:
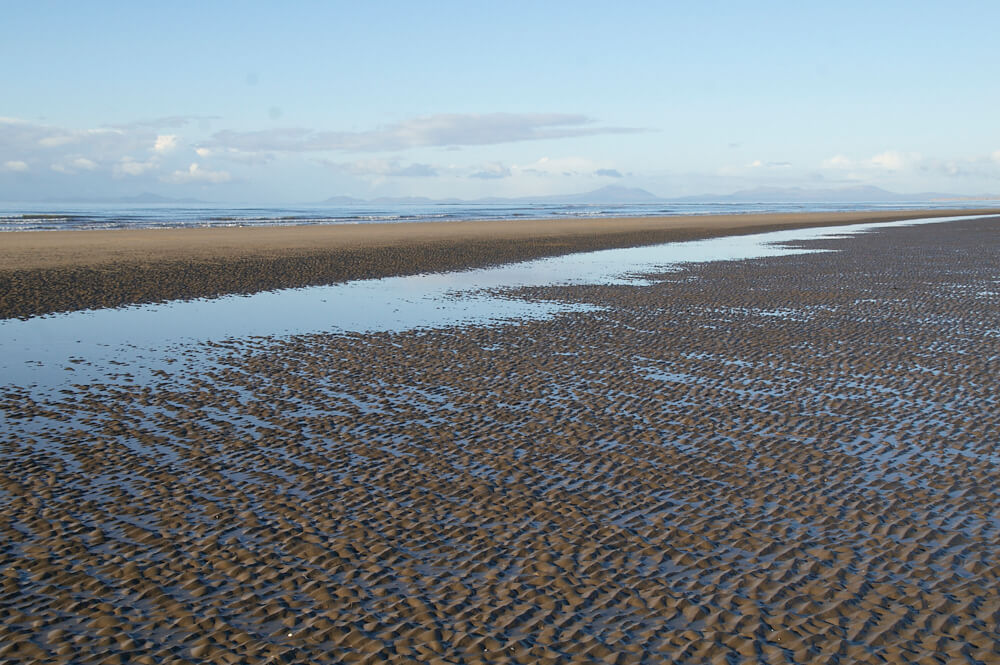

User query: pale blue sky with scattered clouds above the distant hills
[0,0,1000,204]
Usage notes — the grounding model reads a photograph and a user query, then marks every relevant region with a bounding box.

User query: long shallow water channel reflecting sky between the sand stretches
[0,216,973,389]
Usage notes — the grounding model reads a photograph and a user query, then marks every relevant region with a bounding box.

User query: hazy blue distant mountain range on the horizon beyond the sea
[320,185,1000,206]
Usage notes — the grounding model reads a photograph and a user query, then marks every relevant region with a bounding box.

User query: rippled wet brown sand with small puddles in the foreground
[0,218,1000,665]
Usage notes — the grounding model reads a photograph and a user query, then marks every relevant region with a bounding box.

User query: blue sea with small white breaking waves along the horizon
[0,201,995,231]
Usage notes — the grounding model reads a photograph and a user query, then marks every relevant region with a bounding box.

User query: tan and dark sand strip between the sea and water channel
[0,209,1000,318]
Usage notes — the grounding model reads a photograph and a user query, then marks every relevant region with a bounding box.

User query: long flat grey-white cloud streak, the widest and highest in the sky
[201,113,645,152]
